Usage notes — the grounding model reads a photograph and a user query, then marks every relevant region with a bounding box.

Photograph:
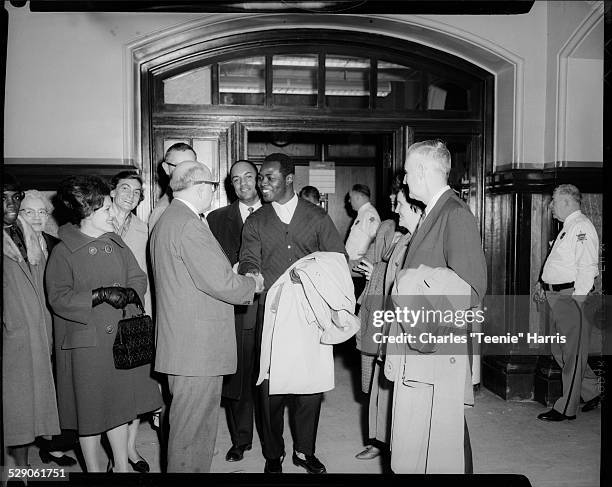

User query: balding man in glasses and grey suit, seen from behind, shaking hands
[150,161,263,472]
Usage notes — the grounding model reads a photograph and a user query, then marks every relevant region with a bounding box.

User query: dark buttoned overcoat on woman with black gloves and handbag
[45,223,162,435]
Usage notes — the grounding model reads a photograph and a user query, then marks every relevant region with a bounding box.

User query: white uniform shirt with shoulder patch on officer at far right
[542,210,599,295]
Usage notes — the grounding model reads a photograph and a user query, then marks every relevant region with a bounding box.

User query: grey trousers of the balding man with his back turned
[168,375,223,473]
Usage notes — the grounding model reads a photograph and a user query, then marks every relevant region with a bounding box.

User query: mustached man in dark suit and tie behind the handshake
[206,160,261,462]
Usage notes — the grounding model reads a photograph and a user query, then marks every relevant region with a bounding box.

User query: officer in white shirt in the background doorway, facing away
[346,184,380,267]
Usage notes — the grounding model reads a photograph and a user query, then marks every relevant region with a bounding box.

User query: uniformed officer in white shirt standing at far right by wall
[534,184,600,421]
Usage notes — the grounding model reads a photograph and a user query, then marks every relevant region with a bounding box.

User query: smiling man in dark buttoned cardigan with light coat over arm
[238,154,345,473]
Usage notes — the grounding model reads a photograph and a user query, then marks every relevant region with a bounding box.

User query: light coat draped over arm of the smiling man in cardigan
[257,252,360,394]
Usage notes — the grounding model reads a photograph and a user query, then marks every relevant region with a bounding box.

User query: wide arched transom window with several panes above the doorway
[155,49,481,116]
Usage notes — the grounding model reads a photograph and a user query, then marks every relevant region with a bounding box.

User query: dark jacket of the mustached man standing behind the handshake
[206,201,259,399]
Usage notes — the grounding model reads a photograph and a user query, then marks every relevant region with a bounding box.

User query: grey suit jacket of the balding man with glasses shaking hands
[151,199,255,376]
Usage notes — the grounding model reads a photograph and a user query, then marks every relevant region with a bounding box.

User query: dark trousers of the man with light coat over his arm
[257,379,323,460]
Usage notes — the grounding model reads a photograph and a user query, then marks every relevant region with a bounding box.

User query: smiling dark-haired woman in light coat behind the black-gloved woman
[110,171,151,473]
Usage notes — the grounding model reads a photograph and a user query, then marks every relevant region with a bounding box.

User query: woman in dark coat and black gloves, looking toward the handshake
[46,176,162,472]
